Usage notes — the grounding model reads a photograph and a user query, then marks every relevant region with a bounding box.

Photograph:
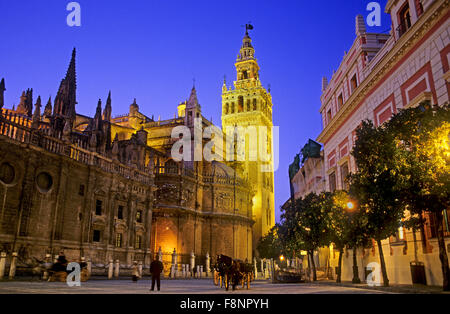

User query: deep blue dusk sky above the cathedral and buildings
[0,0,390,221]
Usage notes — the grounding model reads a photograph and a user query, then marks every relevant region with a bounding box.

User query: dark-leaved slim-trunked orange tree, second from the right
[349,120,404,286]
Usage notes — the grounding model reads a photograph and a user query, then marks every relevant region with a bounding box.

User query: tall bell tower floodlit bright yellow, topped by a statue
[222,24,275,253]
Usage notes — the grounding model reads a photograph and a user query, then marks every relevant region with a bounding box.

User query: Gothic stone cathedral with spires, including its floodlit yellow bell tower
[0,28,275,270]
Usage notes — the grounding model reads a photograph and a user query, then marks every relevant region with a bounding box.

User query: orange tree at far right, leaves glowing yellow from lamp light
[386,103,450,291]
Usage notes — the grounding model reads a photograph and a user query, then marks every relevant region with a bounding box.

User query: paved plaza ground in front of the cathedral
[0,279,392,294]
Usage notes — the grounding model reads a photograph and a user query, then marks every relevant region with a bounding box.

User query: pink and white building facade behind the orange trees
[317,0,450,285]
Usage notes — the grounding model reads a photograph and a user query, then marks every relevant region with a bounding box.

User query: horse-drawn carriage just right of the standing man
[213,255,253,291]
